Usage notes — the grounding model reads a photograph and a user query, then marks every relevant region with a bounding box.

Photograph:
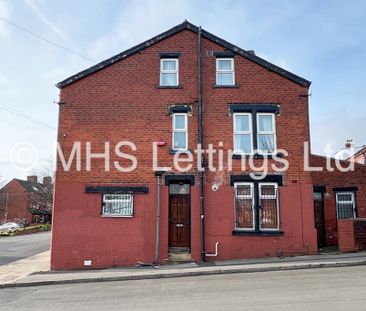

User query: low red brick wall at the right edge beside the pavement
[338,218,366,252]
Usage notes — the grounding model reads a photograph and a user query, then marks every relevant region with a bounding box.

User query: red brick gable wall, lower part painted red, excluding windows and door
[52,30,316,269]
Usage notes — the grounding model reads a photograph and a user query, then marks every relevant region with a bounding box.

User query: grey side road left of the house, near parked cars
[0,232,51,266]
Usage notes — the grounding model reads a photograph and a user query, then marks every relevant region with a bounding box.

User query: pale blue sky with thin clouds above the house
[0,0,366,181]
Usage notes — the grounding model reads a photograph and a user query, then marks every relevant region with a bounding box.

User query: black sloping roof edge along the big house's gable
[56,21,311,89]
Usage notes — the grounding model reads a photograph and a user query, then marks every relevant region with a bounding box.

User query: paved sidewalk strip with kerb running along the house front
[0,253,366,288]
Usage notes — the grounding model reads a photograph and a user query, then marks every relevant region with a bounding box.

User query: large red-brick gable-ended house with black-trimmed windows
[51,21,366,269]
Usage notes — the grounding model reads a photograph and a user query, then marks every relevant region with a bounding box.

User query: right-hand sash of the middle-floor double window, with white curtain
[257,113,276,153]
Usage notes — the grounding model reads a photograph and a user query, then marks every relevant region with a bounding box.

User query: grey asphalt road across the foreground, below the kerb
[0,266,366,311]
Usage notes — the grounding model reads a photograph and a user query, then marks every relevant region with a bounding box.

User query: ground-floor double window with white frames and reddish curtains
[234,182,279,231]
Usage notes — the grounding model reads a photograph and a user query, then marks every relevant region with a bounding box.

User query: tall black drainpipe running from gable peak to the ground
[198,26,206,262]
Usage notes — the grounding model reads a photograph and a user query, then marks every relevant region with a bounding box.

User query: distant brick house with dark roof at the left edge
[0,176,53,224]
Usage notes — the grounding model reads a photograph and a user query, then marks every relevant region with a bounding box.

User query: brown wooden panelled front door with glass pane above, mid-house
[169,184,191,248]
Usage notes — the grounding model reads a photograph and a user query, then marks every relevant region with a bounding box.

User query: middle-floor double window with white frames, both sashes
[233,112,277,154]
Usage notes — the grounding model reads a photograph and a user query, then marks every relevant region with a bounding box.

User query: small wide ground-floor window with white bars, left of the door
[102,194,133,217]
